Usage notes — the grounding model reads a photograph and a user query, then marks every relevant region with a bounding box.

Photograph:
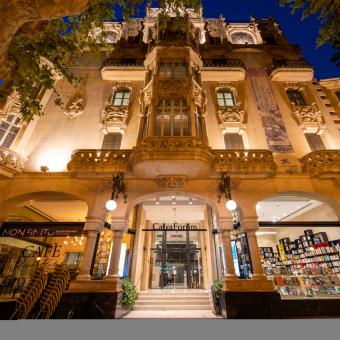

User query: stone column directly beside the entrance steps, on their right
[217,219,237,280]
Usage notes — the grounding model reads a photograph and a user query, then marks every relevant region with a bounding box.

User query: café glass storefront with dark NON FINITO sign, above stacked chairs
[0,222,86,296]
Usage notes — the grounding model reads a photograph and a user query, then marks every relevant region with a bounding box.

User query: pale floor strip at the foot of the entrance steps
[123,310,220,319]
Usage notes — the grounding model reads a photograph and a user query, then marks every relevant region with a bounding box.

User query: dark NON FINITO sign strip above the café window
[0,222,85,237]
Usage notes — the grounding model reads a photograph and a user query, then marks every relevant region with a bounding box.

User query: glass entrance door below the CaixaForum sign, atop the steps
[150,230,202,289]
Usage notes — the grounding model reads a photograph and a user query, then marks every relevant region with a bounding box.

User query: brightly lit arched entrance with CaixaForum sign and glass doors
[127,192,221,290]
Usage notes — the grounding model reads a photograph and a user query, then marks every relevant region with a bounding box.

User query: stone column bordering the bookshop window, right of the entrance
[241,217,267,280]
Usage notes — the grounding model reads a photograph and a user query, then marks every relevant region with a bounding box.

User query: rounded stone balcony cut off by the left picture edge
[0,146,25,178]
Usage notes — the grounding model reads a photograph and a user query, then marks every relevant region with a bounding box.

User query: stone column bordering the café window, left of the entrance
[77,218,104,281]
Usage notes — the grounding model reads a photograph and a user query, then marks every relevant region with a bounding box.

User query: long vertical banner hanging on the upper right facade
[247,68,294,152]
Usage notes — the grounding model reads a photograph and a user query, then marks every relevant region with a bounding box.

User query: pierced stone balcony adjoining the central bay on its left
[67,149,131,177]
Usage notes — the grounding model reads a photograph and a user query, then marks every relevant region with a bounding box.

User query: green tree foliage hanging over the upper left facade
[0,0,199,121]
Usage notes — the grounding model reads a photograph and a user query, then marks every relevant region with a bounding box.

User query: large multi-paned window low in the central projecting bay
[154,99,190,137]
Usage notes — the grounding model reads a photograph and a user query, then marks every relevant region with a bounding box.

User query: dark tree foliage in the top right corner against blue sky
[280,0,340,66]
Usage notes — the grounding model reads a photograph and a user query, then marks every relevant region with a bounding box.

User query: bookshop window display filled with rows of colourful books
[260,230,340,298]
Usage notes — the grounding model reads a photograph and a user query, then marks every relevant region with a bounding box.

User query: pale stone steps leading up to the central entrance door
[133,289,211,311]
